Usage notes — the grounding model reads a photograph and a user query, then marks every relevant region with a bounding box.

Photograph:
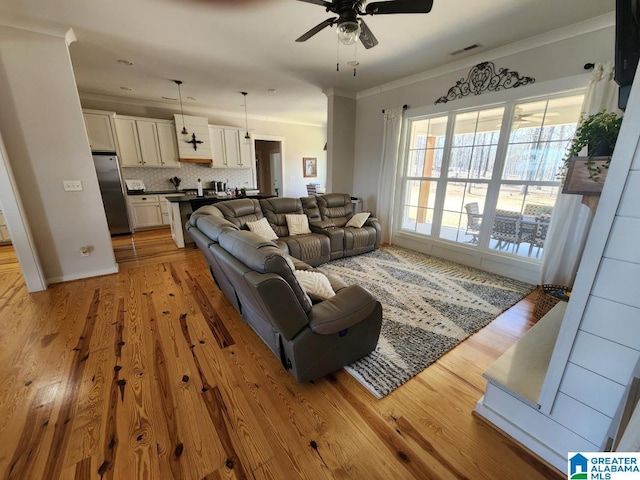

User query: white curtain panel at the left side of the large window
[376,107,404,243]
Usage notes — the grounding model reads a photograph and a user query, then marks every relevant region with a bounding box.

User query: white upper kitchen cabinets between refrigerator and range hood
[115,117,180,168]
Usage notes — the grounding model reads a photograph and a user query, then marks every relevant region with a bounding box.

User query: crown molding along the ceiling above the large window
[356,12,616,100]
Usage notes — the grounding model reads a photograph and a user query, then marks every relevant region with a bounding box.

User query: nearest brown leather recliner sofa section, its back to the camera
[187,214,382,382]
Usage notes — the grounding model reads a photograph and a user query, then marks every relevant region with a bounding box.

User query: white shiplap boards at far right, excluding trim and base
[551,108,640,454]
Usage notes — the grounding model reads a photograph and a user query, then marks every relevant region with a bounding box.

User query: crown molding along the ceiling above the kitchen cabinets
[78,90,326,127]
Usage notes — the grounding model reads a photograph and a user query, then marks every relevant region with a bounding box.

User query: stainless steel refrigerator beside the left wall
[93,152,131,235]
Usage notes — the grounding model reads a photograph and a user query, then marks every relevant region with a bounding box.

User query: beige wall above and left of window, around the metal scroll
[353,22,615,216]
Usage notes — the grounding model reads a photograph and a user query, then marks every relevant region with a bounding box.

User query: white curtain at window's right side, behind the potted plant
[540,62,621,286]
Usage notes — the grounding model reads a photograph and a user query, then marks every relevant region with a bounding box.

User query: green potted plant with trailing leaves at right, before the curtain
[563,110,622,193]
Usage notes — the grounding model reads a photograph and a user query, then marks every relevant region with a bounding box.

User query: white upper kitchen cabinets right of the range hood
[209,125,252,168]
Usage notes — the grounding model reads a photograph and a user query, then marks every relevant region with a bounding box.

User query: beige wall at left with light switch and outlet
[0,26,117,282]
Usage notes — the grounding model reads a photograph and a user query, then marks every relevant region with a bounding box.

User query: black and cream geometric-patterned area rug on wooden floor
[319,246,534,398]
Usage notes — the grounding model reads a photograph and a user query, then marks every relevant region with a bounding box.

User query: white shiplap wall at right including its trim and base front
[476,74,640,471]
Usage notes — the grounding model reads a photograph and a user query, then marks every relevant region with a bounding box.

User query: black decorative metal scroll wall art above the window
[434,62,536,105]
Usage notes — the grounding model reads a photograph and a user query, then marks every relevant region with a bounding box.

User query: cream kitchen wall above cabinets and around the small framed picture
[80,94,327,197]
